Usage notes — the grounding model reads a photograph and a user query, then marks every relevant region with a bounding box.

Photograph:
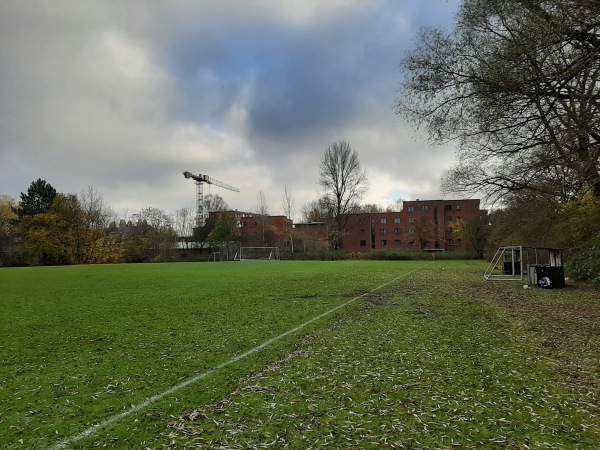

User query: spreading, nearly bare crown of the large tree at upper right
[396,0,600,200]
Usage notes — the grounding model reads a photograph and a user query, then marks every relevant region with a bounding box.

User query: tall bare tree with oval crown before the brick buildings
[319,141,368,249]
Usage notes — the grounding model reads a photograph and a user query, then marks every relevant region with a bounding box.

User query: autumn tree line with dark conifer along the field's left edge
[0,179,234,266]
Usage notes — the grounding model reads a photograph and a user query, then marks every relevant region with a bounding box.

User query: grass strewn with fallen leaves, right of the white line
[164,263,600,449]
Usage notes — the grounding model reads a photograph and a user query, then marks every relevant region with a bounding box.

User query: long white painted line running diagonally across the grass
[50,262,433,450]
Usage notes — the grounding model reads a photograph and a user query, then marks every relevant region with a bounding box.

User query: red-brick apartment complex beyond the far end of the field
[213,199,487,252]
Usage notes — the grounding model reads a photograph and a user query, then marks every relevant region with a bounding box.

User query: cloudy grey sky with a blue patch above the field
[0,0,458,219]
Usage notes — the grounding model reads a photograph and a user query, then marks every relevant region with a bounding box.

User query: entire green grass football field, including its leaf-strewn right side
[0,261,600,449]
